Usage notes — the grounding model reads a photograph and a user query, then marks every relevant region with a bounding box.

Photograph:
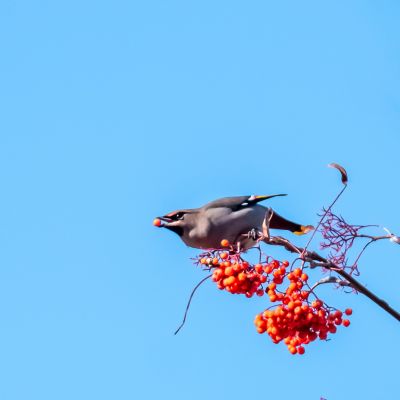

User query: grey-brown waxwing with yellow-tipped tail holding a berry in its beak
[155,194,314,250]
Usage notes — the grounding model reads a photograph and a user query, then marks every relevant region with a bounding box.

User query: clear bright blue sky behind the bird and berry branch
[0,0,400,400]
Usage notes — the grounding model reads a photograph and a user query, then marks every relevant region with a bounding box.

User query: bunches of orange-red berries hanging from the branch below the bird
[198,241,352,354]
